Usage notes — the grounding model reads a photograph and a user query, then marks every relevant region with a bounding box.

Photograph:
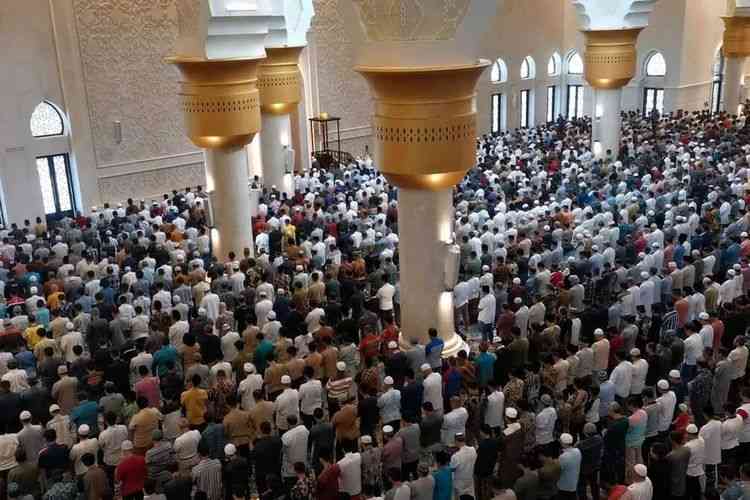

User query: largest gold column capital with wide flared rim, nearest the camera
[354,60,490,191]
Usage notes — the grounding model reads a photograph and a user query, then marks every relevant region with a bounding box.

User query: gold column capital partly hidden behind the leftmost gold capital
[258,46,305,115]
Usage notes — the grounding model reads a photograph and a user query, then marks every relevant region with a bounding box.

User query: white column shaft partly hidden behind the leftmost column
[260,113,294,197]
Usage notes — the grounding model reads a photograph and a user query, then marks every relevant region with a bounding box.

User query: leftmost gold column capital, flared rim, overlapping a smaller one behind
[165,57,260,149]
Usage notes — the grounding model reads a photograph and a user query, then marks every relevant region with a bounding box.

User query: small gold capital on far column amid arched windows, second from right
[583,28,643,89]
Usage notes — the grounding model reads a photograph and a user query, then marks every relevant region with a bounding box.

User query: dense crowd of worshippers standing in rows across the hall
[0,107,750,500]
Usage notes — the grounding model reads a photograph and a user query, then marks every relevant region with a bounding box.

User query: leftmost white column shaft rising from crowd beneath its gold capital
[205,146,253,261]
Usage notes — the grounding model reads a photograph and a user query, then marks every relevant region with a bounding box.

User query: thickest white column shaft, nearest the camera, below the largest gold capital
[398,188,461,354]
